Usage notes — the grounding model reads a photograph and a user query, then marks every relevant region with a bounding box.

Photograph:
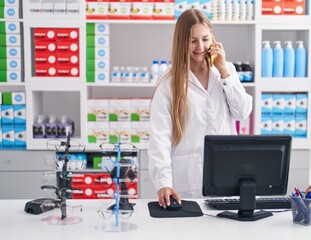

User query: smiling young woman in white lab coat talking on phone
[148,9,252,208]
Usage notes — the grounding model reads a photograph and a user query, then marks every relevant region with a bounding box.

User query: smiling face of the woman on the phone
[190,24,212,63]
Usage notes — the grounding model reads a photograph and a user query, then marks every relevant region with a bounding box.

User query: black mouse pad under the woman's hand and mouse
[148,200,203,218]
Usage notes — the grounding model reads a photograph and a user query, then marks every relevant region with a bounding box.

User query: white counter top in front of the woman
[0,199,311,240]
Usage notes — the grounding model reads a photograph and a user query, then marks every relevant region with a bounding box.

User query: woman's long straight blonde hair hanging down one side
[171,9,212,145]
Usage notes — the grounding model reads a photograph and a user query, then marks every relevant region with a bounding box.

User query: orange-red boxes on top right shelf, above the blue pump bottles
[261,0,307,15]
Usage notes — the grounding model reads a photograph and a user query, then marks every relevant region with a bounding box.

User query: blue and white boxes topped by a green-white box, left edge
[0,92,26,149]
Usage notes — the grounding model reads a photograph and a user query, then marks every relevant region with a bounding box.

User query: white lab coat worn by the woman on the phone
[148,63,252,198]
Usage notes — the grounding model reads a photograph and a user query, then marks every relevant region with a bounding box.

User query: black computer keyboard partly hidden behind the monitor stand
[204,197,291,210]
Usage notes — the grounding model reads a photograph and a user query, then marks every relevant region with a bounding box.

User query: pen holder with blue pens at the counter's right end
[290,195,311,225]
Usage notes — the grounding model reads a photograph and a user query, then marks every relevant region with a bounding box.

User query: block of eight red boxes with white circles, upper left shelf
[33,28,80,77]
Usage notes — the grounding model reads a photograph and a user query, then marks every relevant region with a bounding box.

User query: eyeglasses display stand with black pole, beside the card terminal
[41,132,82,225]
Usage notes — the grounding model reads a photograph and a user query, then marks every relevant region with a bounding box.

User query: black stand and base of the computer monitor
[217,179,273,221]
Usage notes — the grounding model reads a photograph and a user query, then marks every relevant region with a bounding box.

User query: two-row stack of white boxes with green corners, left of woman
[88,99,150,145]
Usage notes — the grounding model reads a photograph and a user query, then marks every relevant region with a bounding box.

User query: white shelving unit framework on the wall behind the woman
[0,1,311,199]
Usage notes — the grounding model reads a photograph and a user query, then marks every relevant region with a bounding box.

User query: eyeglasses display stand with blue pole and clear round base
[96,143,137,232]
